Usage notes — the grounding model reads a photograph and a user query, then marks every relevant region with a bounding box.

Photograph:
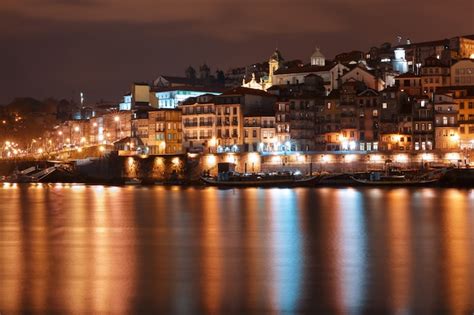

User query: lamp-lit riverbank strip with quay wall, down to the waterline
[0,152,474,187]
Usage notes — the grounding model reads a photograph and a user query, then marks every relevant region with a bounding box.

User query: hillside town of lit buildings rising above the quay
[0,35,474,170]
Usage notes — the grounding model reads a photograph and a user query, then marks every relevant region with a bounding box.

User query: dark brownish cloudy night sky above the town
[0,0,474,103]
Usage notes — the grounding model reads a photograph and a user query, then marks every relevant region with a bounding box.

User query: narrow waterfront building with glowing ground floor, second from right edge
[434,93,460,150]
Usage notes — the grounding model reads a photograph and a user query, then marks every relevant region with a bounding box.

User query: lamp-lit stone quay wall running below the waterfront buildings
[0,151,474,182]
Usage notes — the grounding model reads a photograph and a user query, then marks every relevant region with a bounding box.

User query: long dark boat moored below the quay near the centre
[201,172,319,187]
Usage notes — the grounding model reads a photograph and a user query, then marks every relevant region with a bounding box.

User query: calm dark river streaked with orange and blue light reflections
[0,185,474,315]
